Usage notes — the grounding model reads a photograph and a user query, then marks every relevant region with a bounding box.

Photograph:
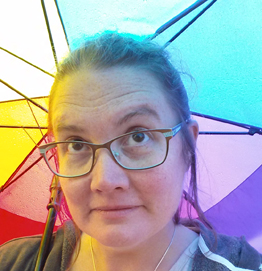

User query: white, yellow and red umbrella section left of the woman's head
[0,0,68,243]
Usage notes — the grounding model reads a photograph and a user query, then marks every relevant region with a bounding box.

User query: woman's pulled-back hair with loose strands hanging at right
[49,32,213,232]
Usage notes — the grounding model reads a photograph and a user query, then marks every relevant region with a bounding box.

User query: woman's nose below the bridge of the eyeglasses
[90,149,129,193]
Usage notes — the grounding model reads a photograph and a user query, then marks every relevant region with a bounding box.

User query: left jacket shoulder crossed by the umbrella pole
[0,223,75,271]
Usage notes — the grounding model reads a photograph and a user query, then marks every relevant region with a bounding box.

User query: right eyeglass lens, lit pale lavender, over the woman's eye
[111,131,167,169]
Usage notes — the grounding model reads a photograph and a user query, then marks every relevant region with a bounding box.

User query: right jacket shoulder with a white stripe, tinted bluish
[193,224,262,270]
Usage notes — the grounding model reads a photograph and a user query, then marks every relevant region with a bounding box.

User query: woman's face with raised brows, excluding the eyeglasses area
[52,67,198,250]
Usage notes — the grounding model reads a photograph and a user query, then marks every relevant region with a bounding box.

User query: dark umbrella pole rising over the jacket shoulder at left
[34,175,62,271]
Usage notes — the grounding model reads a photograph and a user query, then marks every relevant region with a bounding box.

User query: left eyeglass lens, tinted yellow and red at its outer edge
[44,141,93,176]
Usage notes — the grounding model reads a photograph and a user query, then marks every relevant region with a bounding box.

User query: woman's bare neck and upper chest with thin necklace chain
[70,225,196,271]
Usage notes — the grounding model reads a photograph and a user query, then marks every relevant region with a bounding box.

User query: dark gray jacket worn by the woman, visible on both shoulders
[0,222,262,271]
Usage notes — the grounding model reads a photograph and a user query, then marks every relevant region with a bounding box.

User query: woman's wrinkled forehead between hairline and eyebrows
[54,67,166,103]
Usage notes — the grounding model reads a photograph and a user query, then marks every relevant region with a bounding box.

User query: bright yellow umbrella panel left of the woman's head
[0,98,48,186]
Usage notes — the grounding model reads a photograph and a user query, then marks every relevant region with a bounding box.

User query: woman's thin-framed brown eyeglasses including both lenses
[39,122,184,178]
